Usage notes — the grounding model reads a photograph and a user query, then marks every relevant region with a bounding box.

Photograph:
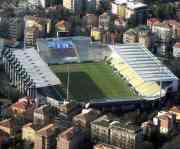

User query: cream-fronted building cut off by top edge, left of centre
[63,0,83,14]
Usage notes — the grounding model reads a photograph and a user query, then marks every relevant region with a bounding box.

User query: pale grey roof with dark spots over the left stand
[13,48,61,88]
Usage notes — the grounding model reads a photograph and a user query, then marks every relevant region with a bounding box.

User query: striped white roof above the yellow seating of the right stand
[109,43,178,82]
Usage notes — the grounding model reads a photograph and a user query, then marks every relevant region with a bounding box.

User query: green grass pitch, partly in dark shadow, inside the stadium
[50,63,135,101]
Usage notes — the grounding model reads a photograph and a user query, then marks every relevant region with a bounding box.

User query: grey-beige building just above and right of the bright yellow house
[99,12,111,31]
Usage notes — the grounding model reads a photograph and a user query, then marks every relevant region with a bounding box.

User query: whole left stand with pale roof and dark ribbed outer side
[2,48,61,98]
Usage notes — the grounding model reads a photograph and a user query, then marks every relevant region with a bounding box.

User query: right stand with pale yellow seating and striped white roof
[108,43,178,99]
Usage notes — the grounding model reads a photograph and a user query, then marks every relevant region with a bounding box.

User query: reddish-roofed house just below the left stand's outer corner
[10,96,37,121]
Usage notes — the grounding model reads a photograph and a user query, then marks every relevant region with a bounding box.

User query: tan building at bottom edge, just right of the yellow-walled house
[34,124,57,149]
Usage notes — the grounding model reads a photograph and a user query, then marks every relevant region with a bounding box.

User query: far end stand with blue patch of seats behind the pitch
[37,36,111,64]
